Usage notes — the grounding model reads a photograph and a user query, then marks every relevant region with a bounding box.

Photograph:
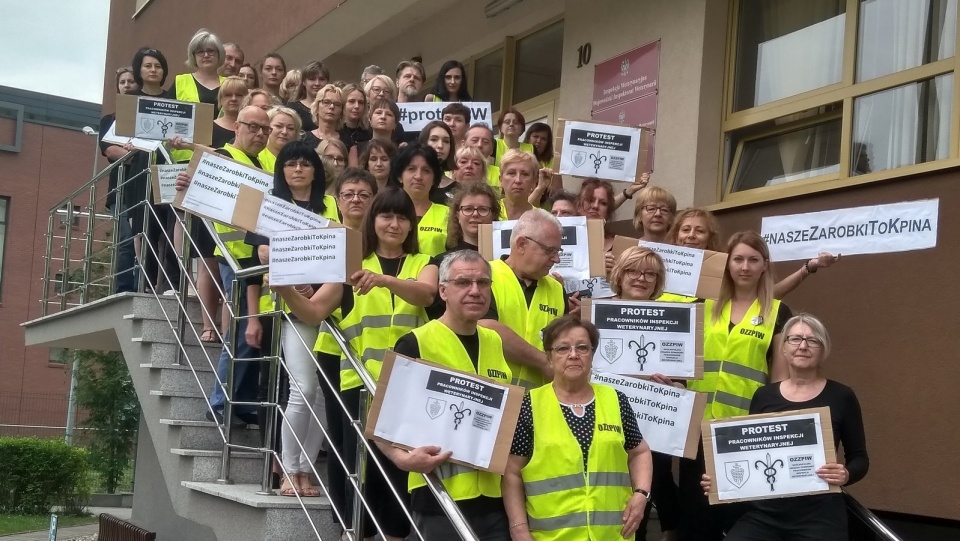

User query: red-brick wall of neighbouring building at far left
[0,119,96,434]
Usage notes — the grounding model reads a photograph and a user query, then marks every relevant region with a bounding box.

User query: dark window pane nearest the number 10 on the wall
[513,21,563,104]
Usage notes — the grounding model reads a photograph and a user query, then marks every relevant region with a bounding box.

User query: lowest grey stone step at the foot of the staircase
[181,481,341,540]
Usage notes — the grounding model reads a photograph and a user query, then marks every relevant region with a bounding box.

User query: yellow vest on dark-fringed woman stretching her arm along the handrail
[340,254,430,391]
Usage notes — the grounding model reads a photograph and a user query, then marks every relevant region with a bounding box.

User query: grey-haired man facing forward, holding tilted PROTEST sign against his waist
[378,250,512,541]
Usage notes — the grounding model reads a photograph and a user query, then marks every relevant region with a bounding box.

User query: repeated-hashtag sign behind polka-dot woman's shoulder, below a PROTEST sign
[591,372,707,459]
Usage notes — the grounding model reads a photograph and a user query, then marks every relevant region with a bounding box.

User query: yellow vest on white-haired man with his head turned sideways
[490,259,566,389]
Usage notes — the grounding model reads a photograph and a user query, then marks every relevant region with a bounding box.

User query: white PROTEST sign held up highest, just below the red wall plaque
[560,120,641,182]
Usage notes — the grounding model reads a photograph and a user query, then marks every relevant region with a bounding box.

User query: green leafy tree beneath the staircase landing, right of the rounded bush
[75,350,140,494]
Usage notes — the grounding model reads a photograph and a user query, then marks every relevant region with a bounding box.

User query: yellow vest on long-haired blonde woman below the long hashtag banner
[687,299,780,420]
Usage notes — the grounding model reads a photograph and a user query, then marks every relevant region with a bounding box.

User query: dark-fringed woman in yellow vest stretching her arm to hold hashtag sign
[276,188,437,539]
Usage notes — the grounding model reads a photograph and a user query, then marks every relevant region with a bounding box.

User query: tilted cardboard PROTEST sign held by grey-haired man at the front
[365,351,524,475]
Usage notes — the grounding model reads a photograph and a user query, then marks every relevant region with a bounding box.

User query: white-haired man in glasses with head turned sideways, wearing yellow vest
[480,209,576,389]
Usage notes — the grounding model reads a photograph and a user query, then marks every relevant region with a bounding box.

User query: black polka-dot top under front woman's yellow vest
[510,391,643,469]
